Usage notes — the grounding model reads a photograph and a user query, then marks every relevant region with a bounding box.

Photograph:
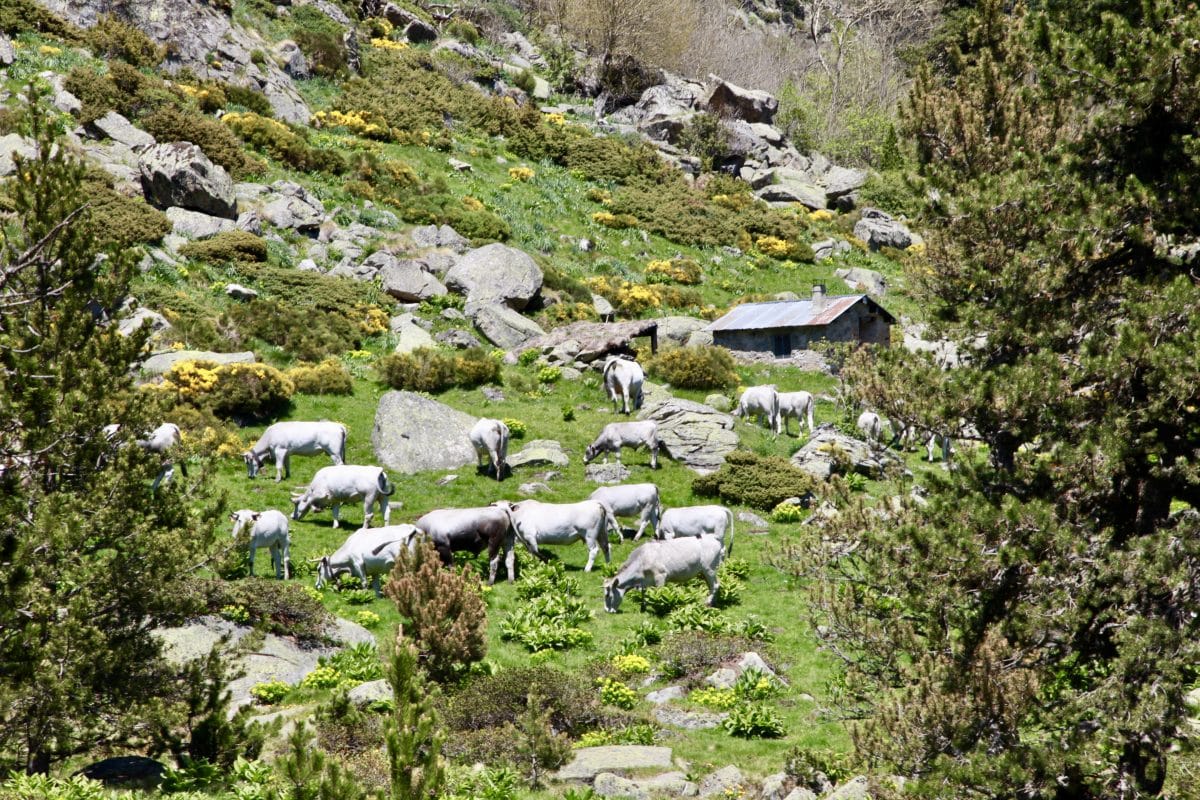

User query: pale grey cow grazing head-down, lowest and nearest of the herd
[604,536,725,614]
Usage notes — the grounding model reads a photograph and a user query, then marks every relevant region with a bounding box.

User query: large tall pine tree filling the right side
[799,0,1200,798]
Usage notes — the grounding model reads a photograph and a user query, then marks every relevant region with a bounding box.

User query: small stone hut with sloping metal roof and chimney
[708,283,896,357]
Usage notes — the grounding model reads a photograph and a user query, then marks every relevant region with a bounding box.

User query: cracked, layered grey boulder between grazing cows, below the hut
[637,397,738,475]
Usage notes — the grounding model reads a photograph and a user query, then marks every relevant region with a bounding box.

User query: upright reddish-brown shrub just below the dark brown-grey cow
[384,542,487,681]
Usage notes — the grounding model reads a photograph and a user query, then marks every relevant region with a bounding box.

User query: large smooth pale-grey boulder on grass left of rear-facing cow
[371,391,478,475]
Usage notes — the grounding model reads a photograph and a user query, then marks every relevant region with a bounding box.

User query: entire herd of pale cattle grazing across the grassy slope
[114,357,949,612]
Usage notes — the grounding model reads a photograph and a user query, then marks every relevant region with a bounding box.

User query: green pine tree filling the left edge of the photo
[0,95,216,772]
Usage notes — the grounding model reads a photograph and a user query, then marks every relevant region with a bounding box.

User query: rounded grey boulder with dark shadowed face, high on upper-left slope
[138,142,238,219]
